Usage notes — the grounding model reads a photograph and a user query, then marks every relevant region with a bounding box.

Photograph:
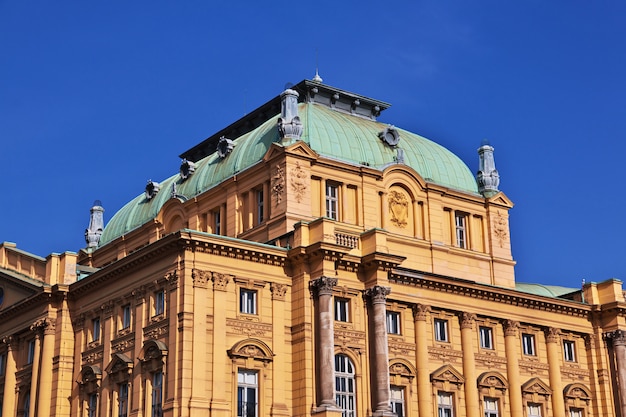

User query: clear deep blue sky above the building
[0,0,626,287]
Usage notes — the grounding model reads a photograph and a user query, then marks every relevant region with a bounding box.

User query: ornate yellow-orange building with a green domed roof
[0,76,626,417]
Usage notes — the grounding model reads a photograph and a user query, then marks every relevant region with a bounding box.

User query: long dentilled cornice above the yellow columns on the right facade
[389,269,592,317]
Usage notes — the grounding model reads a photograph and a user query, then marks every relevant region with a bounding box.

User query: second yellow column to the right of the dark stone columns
[460,312,480,417]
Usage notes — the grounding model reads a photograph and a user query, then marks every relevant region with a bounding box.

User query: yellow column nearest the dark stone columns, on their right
[413,304,433,417]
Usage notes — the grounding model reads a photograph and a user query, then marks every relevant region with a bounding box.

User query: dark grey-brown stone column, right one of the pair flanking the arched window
[365,285,394,417]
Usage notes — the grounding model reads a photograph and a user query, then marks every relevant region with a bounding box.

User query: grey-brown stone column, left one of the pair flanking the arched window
[309,277,339,412]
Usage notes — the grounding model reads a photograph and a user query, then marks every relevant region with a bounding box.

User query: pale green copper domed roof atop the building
[99,94,478,246]
